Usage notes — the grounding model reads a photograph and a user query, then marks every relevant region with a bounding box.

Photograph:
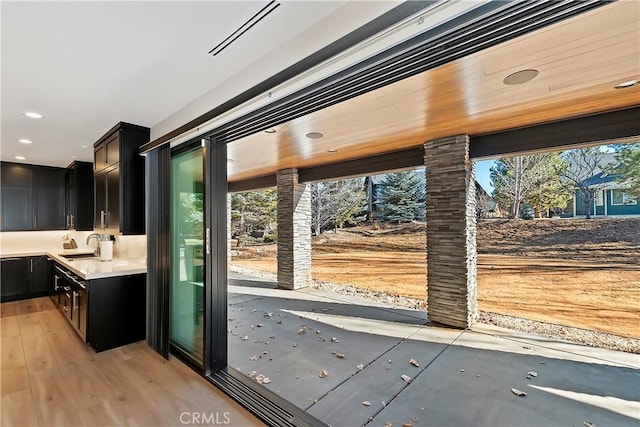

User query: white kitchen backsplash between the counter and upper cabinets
[0,230,147,258]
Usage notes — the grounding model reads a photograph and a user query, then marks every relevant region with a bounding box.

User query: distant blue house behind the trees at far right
[573,172,640,216]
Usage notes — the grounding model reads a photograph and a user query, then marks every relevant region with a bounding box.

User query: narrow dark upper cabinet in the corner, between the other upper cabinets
[65,162,94,231]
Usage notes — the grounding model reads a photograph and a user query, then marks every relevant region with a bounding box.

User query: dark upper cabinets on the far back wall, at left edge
[0,162,65,231]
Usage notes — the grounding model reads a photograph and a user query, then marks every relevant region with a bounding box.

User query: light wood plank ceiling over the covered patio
[228,1,640,181]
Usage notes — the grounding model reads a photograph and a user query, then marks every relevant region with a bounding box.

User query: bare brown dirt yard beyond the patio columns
[232,218,640,338]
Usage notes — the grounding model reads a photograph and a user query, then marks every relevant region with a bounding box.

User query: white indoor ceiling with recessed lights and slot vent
[0,0,397,166]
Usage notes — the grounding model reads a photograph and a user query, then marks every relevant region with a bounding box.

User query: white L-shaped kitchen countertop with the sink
[2,249,147,280]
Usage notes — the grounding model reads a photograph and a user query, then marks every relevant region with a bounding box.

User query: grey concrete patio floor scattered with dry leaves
[228,274,640,427]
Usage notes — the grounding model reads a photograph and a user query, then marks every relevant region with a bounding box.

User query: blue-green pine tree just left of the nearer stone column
[376,171,425,223]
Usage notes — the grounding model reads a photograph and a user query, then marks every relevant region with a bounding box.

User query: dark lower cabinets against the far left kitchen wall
[0,255,50,302]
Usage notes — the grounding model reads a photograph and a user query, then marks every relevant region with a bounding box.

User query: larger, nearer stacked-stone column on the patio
[424,135,478,328]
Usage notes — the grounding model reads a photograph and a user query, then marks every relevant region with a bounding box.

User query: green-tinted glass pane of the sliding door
[169,146,205,366]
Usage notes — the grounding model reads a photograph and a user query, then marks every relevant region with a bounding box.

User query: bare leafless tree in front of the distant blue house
[559,147,609,219]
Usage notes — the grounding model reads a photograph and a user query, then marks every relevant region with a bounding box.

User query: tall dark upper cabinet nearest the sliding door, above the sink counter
[93,122,150,234]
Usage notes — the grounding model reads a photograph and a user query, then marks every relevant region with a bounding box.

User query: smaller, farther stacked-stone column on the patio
[276,169,311,289]
